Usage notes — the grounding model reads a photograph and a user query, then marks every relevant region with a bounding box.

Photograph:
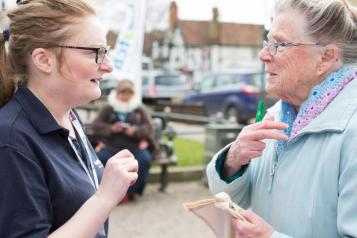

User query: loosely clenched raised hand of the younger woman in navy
[96,150,138,207]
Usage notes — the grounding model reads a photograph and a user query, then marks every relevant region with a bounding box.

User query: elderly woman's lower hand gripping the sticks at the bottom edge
[231,209,274,238]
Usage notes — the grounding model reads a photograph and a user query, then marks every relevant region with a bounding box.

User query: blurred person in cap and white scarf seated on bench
[92,79,156,199]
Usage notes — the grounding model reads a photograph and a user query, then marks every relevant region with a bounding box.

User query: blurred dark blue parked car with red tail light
[182,69,263,123]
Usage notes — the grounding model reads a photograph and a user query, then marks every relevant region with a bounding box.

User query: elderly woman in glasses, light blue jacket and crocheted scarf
[207,0,357,238]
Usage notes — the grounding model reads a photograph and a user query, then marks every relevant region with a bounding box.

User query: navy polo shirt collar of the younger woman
[14,87,63,134]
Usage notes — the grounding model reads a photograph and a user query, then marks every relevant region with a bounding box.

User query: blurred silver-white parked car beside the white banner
[142,71,190,103]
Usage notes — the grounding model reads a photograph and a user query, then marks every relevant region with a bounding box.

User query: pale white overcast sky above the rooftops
[0,0,273,31]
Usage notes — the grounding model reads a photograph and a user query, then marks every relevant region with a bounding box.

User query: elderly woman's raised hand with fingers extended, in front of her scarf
[224,118,288,177]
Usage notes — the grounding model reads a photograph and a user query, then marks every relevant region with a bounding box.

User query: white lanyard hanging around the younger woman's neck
[68,111,107,237]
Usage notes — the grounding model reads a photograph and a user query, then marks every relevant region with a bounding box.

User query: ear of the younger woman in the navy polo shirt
[31,48,55,73]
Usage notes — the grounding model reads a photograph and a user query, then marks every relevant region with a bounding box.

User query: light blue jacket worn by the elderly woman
[207,79,357,238]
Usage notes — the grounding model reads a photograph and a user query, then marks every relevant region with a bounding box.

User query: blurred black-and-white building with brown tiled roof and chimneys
[144,2,264,82]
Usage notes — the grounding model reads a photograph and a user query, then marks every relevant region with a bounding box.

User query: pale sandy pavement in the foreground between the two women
[109,181,215,238]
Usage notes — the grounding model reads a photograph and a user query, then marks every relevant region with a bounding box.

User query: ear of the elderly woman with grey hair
[318,44,342,75]
